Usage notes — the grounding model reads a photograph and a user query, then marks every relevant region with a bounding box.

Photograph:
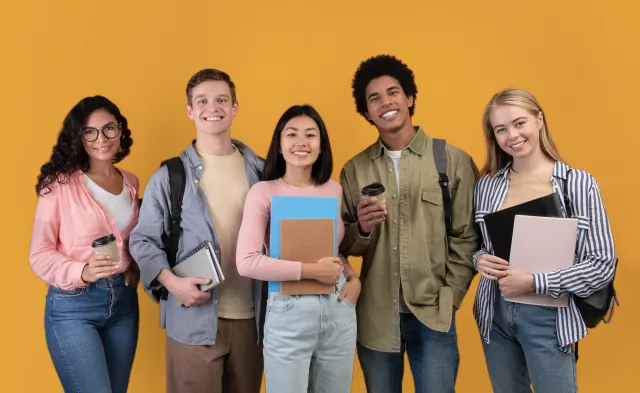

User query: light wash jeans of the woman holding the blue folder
[264,276,357,393]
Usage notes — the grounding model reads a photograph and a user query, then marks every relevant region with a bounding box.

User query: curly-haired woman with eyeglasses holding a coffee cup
[29,96,139,393]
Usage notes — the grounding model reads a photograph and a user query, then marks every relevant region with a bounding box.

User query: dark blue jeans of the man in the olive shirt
[358,313,460,393]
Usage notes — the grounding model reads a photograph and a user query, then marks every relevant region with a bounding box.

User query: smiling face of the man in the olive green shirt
[365,75,413,134]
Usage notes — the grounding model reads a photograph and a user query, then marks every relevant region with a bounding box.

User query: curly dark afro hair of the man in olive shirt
[351,55,418,124]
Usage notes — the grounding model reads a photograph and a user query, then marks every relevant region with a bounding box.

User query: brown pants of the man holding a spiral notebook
[167,318,263,393]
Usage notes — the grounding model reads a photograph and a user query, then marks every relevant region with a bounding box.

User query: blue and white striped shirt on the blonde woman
[473,161,616,351]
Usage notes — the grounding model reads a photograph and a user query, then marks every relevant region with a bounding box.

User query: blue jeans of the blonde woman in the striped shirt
[483,292,577,393]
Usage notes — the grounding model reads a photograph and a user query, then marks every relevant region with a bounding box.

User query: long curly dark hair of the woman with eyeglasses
[36,96,133,195]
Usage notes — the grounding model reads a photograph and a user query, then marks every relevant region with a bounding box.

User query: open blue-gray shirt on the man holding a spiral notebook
[129,140,267,345]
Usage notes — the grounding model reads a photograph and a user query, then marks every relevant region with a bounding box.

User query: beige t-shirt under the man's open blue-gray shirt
[198,149,254,319]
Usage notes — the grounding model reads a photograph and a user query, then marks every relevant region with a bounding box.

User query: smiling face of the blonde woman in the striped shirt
[489,105,544,159]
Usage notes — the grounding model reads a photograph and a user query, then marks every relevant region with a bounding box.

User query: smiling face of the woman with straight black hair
[280,116,320,172]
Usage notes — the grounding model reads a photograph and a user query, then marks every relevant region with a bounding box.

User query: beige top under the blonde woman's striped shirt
[500,166,553,210]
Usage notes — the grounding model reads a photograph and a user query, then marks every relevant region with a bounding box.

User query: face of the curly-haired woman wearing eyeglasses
[82,109,121,163]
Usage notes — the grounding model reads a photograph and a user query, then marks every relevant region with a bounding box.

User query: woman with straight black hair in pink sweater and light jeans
[237,105,360,393]
